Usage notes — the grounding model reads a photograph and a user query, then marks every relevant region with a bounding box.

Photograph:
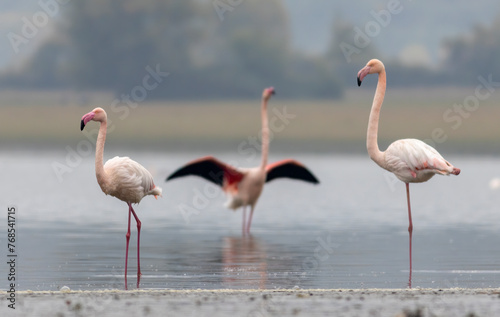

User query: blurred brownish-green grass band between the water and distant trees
[0,87,500,154]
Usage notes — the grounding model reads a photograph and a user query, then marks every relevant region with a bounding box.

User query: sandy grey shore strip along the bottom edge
[0,288,500,317]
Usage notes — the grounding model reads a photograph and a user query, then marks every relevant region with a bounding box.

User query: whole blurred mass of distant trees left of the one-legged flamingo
[0,0,341,99]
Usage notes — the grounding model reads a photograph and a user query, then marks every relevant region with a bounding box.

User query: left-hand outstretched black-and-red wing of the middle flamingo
[166,156,244,187]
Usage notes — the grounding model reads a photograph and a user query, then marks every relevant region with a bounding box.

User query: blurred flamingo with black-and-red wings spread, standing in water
[166,87,319,234]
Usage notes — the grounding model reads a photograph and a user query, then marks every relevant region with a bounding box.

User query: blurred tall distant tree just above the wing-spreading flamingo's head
[205,0,291,97]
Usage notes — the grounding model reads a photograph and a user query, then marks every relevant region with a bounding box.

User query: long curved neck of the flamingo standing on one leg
[366,70,386,167]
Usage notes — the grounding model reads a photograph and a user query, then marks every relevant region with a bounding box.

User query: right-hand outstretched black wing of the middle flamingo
[266,159,319,184]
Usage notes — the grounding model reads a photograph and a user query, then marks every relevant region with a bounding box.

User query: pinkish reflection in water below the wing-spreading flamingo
[222,235,267,289]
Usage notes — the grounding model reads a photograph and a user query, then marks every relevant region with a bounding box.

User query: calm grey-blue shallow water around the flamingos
[0,150,500,290]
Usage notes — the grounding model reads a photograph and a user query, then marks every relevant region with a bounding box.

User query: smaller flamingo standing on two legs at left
[80,108,162,289]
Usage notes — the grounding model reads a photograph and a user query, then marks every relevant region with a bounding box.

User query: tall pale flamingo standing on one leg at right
[358,59,460,288]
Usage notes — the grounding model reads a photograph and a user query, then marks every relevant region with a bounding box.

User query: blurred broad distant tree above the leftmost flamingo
[61,0,204,91]
